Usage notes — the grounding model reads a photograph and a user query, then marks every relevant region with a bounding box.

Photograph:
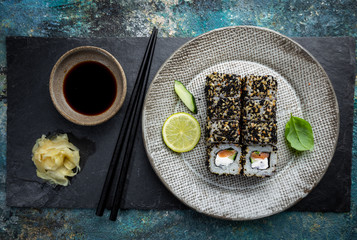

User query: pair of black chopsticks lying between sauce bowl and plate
[96,27,158,221]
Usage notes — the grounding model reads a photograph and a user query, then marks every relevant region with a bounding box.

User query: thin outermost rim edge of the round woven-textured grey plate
[141,25,340,221]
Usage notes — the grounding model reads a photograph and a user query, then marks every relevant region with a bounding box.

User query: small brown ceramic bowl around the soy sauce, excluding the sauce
[49,46,126,126]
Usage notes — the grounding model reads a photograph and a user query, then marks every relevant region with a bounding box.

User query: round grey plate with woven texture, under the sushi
[143,26,339,220]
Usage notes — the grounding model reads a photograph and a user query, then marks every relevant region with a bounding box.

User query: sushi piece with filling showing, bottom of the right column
[242,145,278,177]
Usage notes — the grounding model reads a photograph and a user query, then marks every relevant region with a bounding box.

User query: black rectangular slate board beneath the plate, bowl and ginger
[6,37,355,212]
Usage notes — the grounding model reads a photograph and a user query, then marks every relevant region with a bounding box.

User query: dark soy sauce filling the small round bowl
[63,61,117,116]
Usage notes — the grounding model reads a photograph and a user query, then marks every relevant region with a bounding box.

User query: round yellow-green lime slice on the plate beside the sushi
[162,112,201,152]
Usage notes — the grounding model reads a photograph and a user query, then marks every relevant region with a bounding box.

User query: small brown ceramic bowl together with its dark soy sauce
[48,46,127,126]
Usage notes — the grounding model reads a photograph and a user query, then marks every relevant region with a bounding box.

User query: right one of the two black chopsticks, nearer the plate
[109,28,156,221]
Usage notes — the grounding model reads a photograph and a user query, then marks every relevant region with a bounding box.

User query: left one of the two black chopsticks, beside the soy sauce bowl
[96,28,157,216]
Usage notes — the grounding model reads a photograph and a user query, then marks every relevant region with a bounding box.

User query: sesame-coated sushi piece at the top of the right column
[243,75,278,99]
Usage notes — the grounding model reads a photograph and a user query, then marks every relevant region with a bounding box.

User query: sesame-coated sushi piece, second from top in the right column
[242,99,276,122]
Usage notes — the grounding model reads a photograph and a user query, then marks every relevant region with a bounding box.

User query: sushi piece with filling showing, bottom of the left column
[207,144,242,175]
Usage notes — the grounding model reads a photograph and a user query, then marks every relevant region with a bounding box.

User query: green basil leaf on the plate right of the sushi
[285,114,314,151]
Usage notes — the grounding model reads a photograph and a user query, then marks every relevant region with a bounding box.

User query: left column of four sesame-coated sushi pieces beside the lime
[205,72,242,175]
